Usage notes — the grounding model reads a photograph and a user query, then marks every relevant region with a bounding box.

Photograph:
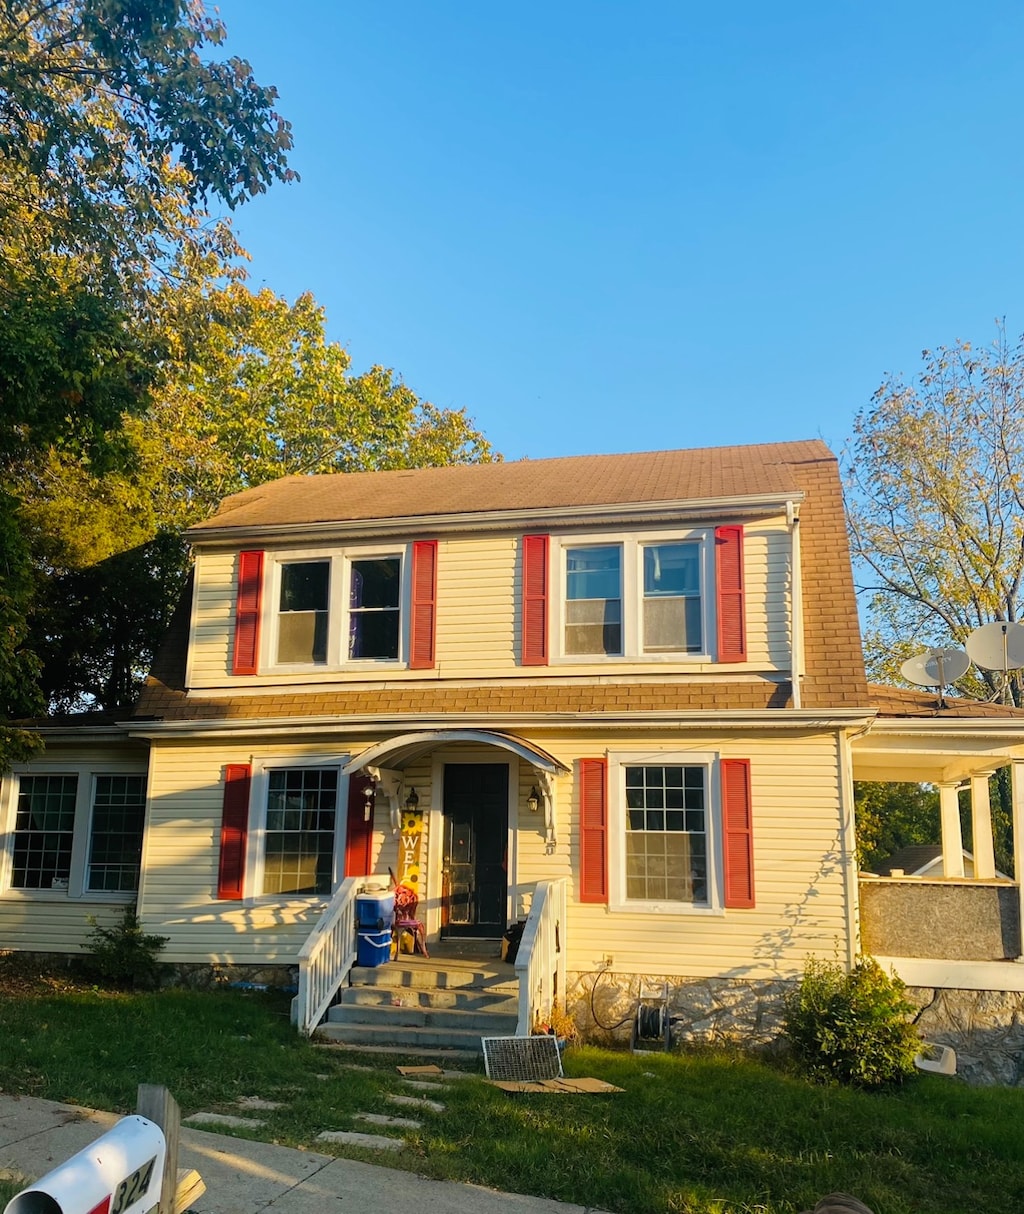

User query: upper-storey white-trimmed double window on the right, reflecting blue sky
[556,531,714,662]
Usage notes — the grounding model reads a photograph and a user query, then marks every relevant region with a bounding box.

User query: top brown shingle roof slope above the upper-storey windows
[189,439,832,539]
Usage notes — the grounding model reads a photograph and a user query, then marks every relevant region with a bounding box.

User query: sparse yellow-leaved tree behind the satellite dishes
[845,329,1024,705]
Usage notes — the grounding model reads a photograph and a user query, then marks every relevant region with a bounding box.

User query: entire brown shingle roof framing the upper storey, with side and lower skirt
[136,439,869,720]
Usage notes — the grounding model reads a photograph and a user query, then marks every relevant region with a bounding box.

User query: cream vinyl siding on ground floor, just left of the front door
[140,742,394,965]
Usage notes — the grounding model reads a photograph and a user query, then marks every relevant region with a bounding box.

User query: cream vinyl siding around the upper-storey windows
[187,518,792,690]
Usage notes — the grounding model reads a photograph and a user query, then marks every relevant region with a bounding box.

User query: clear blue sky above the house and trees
[212,0,1024,459]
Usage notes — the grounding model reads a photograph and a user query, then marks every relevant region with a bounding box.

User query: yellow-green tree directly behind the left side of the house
[17,282,492,711]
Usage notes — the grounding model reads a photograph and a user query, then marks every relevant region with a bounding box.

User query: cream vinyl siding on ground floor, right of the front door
[519,733,847,978]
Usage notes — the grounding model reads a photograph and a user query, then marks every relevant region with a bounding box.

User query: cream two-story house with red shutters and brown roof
[0,441,1024,1068]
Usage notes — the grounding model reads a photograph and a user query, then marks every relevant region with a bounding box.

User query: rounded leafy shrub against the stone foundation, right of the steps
[783,957,921,1088]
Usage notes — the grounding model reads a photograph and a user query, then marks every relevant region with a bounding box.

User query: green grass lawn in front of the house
[0,966,1024,1214]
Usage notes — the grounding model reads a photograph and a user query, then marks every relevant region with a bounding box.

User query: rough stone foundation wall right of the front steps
[566,972,1024,1087]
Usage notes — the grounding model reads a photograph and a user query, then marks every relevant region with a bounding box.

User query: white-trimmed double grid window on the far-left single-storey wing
[6,770,146,897]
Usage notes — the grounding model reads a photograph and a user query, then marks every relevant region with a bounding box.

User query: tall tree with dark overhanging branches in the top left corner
[0,0,292,768]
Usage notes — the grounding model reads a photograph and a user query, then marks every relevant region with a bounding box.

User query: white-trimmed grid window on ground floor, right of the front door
[609,751,720,912]
